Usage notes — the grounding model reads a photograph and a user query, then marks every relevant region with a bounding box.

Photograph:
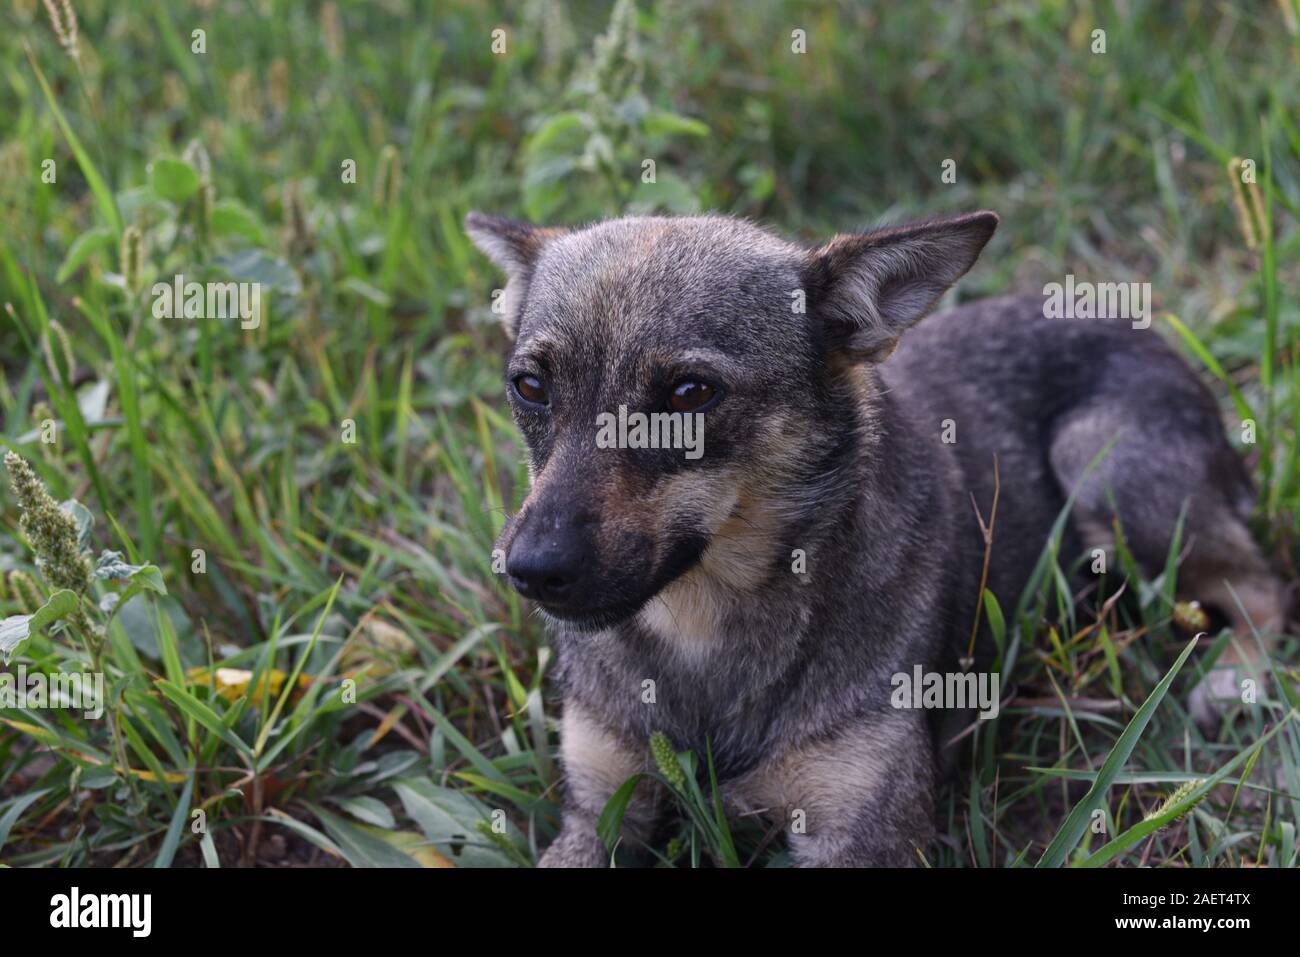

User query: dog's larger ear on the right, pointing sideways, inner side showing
[805,212,997,363]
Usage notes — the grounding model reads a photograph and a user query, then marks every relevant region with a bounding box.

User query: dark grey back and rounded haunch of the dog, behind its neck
[881,298,1253,629]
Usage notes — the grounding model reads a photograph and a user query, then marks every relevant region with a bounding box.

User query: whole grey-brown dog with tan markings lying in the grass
[467,212,1283,866]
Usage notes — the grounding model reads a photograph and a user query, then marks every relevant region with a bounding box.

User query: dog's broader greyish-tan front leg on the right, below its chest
[745,710,936,867]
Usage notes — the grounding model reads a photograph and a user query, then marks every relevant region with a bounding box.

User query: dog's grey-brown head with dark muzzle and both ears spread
[465,212,997,628]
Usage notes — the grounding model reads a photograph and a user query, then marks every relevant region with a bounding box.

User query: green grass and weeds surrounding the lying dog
[0,0,1300,867]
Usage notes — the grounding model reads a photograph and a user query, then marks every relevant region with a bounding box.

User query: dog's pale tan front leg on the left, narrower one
[537,701,655,867]
